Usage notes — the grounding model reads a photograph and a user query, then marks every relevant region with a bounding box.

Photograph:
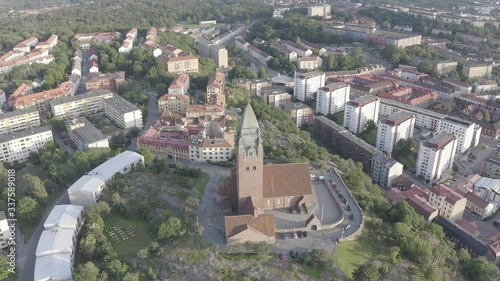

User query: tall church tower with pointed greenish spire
[236,103,264,211]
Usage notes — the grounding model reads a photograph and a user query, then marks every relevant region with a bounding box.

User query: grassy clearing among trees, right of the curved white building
[105,214,153,258]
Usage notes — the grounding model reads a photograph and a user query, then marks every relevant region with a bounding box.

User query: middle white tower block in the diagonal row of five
[343,95,380,134]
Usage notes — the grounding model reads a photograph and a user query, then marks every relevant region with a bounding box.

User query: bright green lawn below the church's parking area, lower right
[334,237,377,279]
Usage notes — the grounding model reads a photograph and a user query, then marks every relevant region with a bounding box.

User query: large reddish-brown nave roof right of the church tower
[264,163,312,198]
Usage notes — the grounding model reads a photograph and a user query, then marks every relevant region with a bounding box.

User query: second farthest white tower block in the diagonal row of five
[316,82,351,115]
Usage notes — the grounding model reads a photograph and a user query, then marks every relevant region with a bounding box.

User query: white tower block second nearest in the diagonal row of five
[377,111,415,155]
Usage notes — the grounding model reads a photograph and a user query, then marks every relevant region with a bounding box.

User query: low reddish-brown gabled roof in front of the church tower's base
[224,214,276,238]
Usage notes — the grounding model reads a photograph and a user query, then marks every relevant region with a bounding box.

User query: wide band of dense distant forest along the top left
[0,0,273,51]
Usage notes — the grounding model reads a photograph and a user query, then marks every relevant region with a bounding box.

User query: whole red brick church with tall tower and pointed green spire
[216,104,314,243]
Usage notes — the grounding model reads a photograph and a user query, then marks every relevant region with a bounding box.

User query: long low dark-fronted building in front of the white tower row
[314,116,379,173]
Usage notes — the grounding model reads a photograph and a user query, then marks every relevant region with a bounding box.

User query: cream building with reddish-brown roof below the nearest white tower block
[429,184,467,221]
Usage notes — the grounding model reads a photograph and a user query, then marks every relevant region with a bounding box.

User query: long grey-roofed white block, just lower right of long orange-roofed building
[51,90,113,119]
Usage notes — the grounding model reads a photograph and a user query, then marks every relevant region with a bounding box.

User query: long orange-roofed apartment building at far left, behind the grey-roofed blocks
[12,82,72,113]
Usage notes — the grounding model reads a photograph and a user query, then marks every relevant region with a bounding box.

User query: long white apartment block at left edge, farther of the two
[0,107,40,136]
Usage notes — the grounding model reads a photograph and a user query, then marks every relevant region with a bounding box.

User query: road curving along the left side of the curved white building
[16,192,70,281]
